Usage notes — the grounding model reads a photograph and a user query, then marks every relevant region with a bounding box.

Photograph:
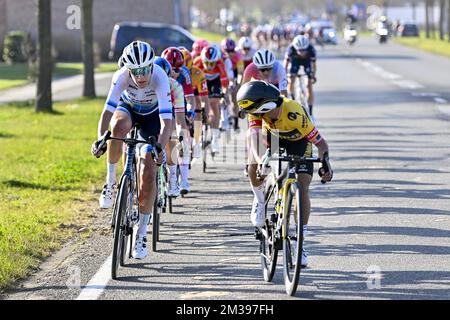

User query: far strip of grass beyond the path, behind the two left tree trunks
[0,62,117,90]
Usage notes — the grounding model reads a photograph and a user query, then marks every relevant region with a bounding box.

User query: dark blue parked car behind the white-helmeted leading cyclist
[108,22,195,60]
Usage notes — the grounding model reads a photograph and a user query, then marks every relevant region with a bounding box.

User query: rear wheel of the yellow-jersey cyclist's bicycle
[259,175,278,282]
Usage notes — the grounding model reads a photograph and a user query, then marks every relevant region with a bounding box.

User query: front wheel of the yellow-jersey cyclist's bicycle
[283,182,304,296]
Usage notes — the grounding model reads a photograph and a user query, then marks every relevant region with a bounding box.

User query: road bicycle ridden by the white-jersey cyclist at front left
[99,126,162,279]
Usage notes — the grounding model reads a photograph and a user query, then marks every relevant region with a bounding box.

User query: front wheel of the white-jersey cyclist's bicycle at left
[111,176,130,279]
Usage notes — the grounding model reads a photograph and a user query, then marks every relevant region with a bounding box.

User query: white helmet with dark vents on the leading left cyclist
[119,41,155,69]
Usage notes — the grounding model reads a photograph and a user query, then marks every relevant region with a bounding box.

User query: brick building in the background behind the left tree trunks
[0,0,190,60]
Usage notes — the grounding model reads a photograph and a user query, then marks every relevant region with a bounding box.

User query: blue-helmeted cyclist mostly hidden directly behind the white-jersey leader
[154,57,189,197]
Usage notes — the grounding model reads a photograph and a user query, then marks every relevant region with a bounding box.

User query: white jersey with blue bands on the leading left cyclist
[105,64,173,119]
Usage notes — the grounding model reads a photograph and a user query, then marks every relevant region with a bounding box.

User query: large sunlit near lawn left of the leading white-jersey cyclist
[0,98,105,290]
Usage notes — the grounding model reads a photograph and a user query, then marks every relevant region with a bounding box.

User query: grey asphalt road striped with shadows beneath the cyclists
[3,39,450,300]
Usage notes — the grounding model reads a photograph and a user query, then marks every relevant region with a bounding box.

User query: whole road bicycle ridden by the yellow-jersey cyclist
[256,149,327,296]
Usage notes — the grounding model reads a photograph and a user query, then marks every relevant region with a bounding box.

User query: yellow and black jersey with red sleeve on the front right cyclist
[248,98,322,144]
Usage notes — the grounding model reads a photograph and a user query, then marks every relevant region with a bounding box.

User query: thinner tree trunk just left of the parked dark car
[82,0,95,98]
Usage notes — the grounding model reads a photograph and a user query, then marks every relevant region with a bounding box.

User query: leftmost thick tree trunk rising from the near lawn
[35,0,53,112]
